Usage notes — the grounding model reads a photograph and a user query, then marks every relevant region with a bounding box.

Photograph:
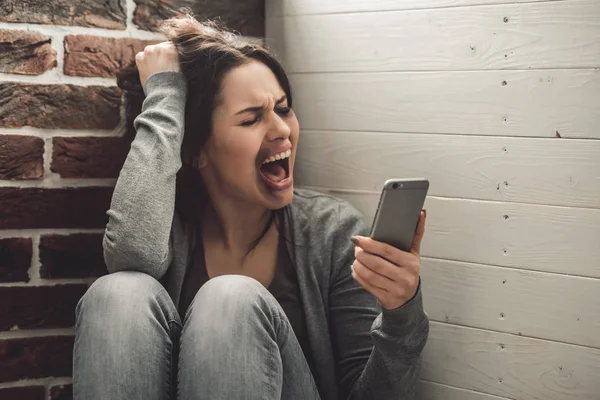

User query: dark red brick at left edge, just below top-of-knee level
[0,284,88,331]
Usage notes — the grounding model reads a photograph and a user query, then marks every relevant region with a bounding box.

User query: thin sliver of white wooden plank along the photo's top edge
[266,0,561,18]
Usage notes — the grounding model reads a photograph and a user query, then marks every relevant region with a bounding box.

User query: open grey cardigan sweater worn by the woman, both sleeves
[103,72,429,400]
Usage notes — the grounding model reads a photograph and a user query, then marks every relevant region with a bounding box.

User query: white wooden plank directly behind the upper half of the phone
[304,188,600,278]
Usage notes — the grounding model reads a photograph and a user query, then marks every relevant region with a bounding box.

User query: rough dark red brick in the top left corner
[0,0,127,30]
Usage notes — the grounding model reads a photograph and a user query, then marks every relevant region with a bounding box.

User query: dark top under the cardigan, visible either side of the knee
[179,230,313,370]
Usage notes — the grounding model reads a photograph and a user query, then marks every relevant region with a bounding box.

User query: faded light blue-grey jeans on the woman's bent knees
[73,272,319,400]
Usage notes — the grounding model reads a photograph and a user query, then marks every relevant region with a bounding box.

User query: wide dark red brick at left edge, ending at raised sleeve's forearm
[0,187,113,229]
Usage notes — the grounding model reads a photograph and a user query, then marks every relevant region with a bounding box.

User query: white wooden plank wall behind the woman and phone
[267,0,600,400]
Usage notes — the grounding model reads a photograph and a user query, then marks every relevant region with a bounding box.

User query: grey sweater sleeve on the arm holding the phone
[330,202,429,400]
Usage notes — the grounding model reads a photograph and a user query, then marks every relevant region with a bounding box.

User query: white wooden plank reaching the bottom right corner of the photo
[421,322,600,400]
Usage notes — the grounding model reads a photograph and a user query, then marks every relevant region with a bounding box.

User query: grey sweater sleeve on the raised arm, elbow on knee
[102,71,187,279]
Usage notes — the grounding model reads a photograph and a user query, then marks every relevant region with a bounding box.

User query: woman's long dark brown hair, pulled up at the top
[117,9,292,251]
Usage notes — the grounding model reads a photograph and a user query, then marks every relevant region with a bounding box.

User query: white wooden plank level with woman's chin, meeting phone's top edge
[295,131,600,208]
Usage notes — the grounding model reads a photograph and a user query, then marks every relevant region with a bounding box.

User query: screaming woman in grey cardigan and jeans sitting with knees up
[73,10,429,400]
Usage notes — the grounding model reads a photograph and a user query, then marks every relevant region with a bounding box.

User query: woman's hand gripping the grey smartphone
[351,211,427,310]
